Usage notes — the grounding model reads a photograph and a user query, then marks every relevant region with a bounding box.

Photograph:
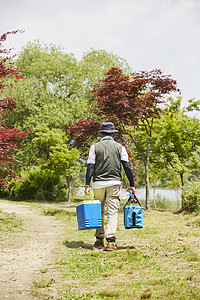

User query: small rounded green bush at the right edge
[182,181,200,212]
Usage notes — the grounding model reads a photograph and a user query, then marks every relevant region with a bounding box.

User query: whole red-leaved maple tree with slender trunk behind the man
[70,68,179,209]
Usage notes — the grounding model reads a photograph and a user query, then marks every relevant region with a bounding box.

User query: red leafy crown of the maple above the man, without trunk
[91,68,178,127]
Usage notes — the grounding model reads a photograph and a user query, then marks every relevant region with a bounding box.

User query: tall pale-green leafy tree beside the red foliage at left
[4,42,84,130]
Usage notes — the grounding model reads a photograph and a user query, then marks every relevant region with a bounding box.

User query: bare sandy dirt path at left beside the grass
[0,202,63,300]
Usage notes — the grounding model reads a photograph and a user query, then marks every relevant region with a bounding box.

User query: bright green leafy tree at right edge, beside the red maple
[151,97,200,207]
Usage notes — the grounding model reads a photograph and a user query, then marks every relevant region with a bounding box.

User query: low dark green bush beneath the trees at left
[10,167,67,201]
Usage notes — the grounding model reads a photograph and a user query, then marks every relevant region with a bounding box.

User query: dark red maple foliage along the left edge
[0,30,27,188]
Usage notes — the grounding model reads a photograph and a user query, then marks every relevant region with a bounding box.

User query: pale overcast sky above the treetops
[0,0,200,105]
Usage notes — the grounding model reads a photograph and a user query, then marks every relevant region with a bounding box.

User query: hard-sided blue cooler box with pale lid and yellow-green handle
[76,194,102,230]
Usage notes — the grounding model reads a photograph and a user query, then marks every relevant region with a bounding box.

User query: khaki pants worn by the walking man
[94,185,121,239]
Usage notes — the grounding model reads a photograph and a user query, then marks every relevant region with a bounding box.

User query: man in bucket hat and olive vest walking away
[85,122,135,251]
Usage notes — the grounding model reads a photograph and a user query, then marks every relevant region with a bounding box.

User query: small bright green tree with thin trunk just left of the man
[32,128,82,202]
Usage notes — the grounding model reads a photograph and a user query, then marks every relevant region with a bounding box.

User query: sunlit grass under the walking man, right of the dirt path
[38,205,200,300]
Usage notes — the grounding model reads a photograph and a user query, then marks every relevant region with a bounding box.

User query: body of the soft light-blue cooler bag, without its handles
[124,205,143,229]
